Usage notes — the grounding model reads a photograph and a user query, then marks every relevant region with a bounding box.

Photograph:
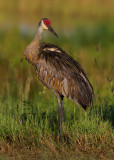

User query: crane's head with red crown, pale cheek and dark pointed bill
[38,18,58,38]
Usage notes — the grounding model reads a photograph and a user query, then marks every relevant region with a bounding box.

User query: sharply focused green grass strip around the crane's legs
[0,95,114,157]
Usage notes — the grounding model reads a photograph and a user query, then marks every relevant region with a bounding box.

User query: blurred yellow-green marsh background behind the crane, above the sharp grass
[0,0,114,100]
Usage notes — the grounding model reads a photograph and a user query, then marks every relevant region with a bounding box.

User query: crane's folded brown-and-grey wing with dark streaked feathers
[36,43,93,107]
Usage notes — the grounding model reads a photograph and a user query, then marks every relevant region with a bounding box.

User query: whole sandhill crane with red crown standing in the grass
[24,18,94,142]
